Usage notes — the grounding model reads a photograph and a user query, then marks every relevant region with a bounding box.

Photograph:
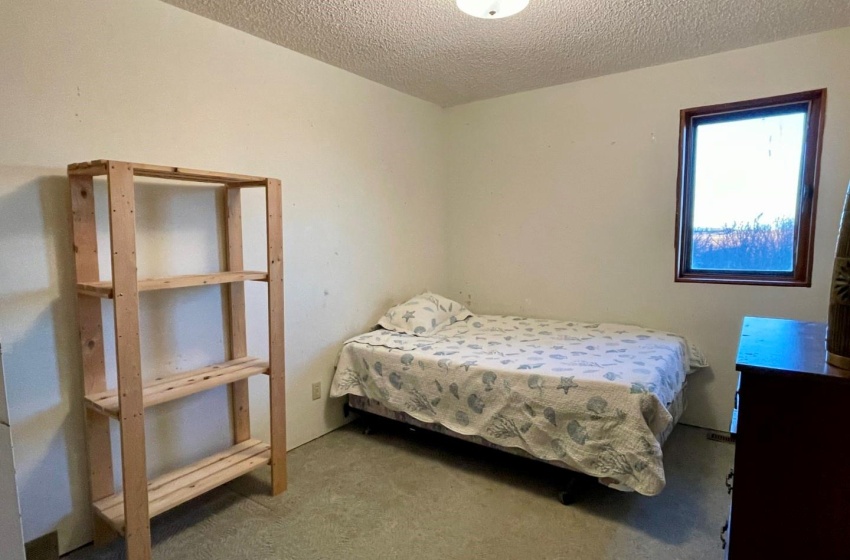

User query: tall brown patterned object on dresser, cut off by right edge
[826,182,850,369]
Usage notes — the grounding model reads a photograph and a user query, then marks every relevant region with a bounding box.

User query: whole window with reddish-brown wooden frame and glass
[676,90,826,286]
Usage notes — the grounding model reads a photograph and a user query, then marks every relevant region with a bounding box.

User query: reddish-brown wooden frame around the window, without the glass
[675,89,826,287]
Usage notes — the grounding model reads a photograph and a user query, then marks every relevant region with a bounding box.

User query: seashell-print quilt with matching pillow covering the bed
[331,293,707,496]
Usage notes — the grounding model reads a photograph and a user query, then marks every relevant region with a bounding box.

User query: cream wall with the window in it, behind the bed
[447,28,850,429]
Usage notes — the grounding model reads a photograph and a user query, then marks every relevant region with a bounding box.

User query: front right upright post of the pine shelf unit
[266,179,286,496]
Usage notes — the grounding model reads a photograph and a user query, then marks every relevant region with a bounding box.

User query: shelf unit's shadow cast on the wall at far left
[0,167,89,550]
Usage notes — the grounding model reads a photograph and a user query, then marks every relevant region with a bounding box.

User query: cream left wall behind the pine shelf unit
[0,0,447,551]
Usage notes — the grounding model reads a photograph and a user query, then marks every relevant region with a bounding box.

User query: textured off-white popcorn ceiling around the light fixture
[165,0,850,106]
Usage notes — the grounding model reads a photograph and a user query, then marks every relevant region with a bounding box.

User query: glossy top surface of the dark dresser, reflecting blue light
[736,317,850,381]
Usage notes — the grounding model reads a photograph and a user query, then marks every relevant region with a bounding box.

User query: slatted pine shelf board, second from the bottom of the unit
[85,357,269,419]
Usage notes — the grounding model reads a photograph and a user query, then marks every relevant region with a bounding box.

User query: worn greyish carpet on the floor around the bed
[69,423,734,560]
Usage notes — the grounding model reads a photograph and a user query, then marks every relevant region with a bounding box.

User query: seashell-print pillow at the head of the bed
[378,292,472,336]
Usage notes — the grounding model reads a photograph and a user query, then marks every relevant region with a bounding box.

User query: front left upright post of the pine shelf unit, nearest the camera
[106,161,151,560]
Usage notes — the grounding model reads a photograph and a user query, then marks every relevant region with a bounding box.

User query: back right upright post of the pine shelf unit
[224,188,251,444]
